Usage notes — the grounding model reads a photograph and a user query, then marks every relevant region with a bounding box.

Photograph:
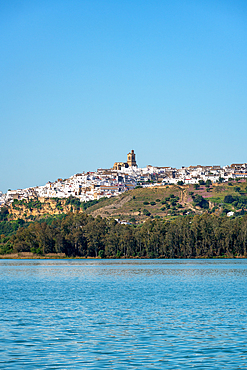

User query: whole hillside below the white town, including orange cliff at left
[1,180,247,223]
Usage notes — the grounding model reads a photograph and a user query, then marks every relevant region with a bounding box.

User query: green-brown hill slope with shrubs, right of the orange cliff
[87,180,247,223]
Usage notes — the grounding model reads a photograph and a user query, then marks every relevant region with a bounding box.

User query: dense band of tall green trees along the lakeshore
[0,213,247,258]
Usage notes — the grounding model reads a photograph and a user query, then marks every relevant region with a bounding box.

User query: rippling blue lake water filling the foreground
[0,260,247,370]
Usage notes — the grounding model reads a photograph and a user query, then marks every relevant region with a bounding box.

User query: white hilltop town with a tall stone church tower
[0,150,247,206]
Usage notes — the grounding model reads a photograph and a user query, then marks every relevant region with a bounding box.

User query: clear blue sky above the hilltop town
[0,0,247,192]
